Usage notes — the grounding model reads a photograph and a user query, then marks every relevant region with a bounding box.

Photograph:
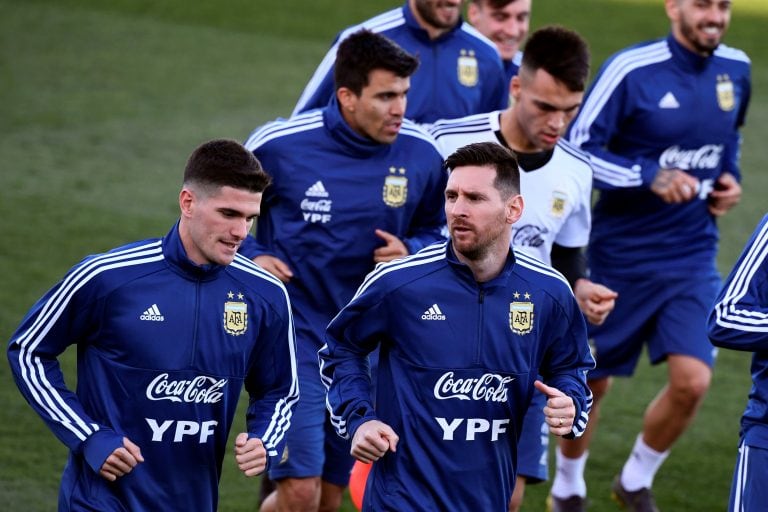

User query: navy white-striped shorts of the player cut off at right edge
[728,442,768,512]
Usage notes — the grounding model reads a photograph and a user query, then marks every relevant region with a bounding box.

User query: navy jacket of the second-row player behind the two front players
[241,100,447,364]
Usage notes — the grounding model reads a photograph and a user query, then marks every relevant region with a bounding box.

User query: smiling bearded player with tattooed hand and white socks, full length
[552,0,750,510]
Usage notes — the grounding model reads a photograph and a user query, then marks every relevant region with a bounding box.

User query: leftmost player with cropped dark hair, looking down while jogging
[8,140,298,511]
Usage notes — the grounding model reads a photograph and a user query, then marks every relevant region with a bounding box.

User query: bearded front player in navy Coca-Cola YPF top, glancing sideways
[319,142,593,511]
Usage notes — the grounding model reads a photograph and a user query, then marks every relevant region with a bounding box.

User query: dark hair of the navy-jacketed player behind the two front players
[333,29,419,96]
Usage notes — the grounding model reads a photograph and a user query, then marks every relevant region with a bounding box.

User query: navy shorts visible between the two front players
[269,340,354,486]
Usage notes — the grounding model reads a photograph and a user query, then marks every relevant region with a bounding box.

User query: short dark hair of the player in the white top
[520,25,589,92]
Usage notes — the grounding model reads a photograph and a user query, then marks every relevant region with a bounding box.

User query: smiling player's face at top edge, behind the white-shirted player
[467,0,531,83]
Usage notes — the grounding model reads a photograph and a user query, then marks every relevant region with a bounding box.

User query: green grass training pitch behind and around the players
[0,0,768,512]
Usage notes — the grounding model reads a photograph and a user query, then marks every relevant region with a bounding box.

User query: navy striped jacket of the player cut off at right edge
[708,215,768,450]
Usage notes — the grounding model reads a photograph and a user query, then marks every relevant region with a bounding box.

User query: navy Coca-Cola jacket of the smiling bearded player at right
[568,35,750,276]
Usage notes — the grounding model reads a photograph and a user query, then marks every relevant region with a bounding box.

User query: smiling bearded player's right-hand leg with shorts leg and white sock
[620,271,720,498]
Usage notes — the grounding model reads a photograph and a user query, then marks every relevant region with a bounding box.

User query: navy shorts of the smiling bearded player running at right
[588,269,721,379]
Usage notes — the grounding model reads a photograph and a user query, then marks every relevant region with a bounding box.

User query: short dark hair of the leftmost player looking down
[184,139,272,193]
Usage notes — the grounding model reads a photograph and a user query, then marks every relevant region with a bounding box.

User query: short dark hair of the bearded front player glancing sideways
[445,142,520,200]
